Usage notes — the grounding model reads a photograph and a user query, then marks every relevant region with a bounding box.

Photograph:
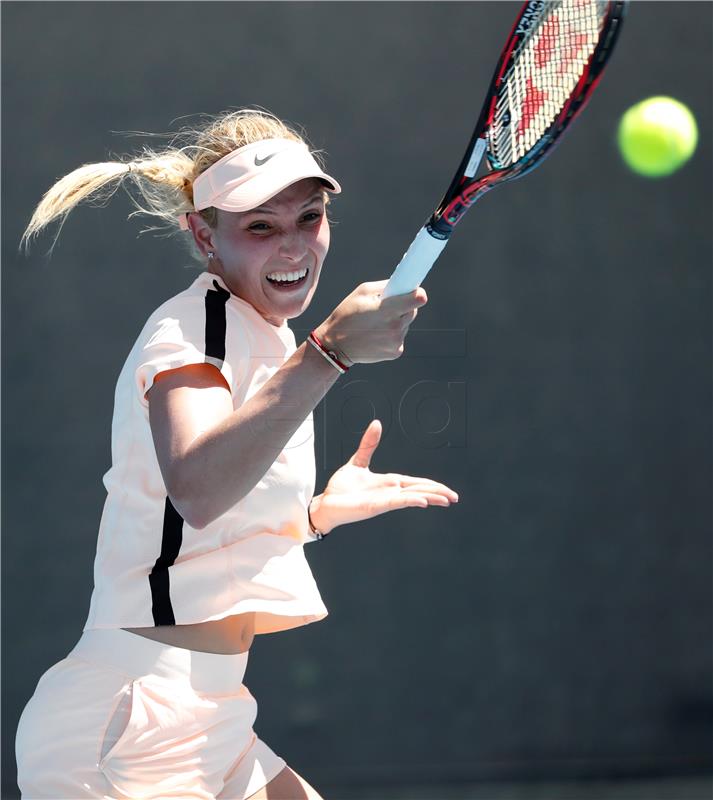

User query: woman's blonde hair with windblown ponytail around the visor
[20,108,327,257]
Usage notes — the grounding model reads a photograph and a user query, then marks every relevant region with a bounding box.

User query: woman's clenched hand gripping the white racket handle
[315,280,428,366]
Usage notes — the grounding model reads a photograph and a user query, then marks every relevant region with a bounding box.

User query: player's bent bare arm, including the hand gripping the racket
[147,281,427,529]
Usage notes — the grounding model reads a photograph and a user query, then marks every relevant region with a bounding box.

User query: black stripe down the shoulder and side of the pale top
[149,281,230,625]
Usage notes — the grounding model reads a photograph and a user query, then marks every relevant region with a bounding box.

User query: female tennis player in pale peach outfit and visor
[16,110,458,800]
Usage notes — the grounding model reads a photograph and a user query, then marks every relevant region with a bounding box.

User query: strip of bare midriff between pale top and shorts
[124,612,255,655]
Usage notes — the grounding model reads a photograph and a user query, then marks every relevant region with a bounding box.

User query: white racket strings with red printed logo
[489,0,608,168]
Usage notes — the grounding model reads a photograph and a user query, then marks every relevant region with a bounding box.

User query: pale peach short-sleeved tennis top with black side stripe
[85,272,327,633]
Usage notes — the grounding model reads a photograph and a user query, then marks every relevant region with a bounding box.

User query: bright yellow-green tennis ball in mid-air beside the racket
[618,97,698,178]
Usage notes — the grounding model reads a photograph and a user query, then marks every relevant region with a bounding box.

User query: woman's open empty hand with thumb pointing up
[310,419,458,533]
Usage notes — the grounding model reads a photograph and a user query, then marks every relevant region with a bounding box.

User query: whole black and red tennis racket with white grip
[382,0,628,297]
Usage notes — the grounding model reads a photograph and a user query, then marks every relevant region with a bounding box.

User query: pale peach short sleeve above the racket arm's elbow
[135,287,237,406]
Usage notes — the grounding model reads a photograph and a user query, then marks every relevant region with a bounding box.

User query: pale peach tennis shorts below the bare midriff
[15,628,285,800]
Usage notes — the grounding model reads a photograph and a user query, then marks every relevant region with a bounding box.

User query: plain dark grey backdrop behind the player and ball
[2,2,713,800]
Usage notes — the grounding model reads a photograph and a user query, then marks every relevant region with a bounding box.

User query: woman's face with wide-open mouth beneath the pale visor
[196,178,329,326]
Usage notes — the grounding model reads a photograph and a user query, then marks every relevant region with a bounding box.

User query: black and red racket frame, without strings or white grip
[426,0,629,239]
